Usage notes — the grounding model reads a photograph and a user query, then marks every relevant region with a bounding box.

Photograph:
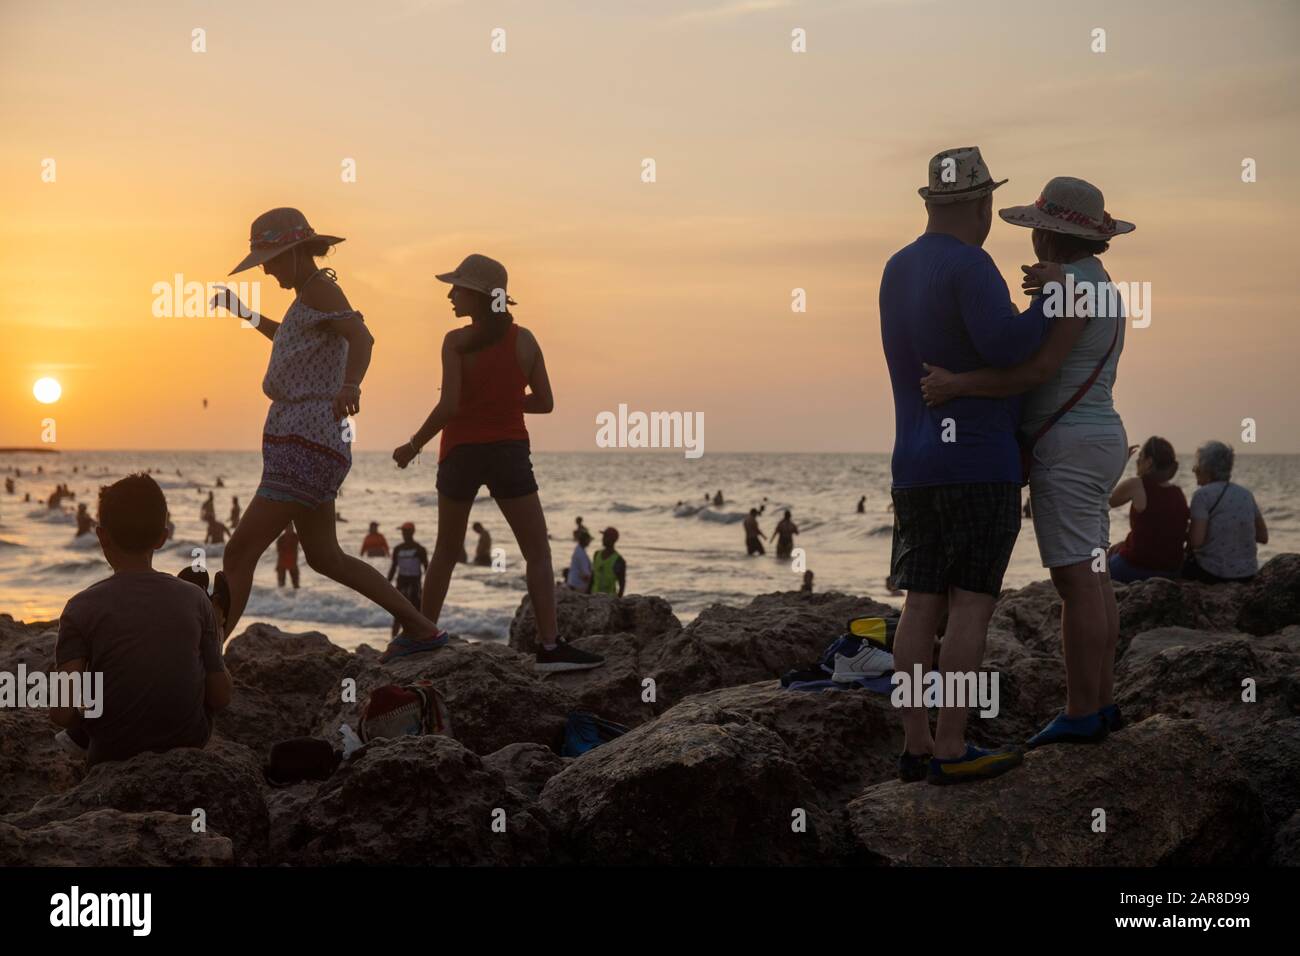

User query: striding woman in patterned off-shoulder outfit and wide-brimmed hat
[205,208,447,644]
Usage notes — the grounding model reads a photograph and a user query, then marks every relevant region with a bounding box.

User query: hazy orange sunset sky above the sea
[0,0,1300,453]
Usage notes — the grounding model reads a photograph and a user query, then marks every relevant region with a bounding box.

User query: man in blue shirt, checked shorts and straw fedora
[880,147,1047,784]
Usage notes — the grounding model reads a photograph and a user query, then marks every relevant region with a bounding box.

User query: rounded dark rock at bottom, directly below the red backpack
[276,735,550,866]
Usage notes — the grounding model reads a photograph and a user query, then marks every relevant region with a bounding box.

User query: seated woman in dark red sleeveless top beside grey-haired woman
[1110,436,1188,584]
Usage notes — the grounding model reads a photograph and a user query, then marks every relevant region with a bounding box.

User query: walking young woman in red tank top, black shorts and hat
[385,255,605,671]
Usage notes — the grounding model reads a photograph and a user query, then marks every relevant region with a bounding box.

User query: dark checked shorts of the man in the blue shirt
[889,483,1021,597]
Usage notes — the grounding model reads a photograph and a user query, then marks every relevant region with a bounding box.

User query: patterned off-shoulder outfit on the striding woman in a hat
[257,299,361,507]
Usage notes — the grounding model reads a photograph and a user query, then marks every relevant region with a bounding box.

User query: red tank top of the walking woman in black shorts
[438,323,528,462]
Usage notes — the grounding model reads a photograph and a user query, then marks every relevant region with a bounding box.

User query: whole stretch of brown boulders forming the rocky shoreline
[0,554,1300,866]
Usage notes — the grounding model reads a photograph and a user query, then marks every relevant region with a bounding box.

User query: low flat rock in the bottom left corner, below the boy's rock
[0,810,234,868]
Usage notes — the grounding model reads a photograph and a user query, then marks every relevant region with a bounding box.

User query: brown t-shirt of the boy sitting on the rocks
[55,571,226,765]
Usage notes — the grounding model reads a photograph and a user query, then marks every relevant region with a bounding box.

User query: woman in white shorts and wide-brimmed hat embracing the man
[922,177,1135,748]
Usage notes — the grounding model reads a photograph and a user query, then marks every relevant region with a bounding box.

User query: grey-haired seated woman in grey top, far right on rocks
[1183,441,1269,584]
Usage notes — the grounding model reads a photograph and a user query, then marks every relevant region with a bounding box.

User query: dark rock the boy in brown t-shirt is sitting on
[4,739,269,864]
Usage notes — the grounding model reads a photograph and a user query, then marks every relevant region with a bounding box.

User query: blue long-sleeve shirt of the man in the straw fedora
[880,233,1048,488]
